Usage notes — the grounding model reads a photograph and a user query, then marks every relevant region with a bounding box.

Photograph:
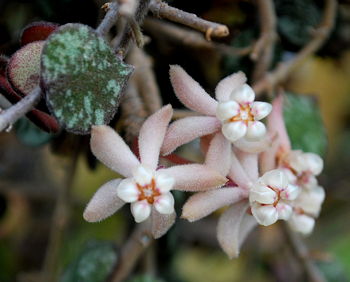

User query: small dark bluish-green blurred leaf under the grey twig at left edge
[14,118,54,147]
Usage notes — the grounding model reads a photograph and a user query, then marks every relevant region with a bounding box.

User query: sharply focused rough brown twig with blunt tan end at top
[149,0,229,40]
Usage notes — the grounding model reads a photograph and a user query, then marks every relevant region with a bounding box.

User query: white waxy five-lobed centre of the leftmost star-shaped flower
[117,165,175,222]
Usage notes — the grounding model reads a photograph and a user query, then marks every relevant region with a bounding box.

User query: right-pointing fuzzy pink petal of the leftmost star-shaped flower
[164,164,227,192]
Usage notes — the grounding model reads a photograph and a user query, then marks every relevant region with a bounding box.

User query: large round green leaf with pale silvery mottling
[41,24,133,134]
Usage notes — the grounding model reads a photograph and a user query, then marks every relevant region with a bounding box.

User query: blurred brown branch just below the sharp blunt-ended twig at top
[143,18,252,56]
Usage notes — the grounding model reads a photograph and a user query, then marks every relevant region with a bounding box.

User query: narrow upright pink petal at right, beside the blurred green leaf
[267,95,291,152]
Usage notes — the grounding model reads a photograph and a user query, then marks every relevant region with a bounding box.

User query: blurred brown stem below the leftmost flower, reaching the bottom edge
[110,223,153,282]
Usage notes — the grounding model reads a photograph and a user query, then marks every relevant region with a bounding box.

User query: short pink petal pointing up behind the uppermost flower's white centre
[215,72,247,102]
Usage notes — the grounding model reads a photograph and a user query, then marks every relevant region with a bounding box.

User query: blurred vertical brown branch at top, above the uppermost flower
[250,0,277,81]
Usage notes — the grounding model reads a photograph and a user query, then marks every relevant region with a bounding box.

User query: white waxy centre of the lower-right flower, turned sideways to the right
[249,169,299,226]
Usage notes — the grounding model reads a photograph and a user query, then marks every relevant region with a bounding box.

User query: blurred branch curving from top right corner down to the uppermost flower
[253,0,337,95]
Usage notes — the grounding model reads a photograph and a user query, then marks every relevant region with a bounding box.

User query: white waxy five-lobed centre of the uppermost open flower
[216,84,272,142]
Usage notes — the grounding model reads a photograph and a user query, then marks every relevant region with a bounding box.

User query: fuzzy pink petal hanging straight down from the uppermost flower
[205,133,232,176]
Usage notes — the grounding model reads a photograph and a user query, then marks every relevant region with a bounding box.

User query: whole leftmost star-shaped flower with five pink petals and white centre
[84,105,226,238]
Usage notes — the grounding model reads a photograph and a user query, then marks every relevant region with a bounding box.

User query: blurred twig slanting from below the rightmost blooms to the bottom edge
[282,224,326,282]
